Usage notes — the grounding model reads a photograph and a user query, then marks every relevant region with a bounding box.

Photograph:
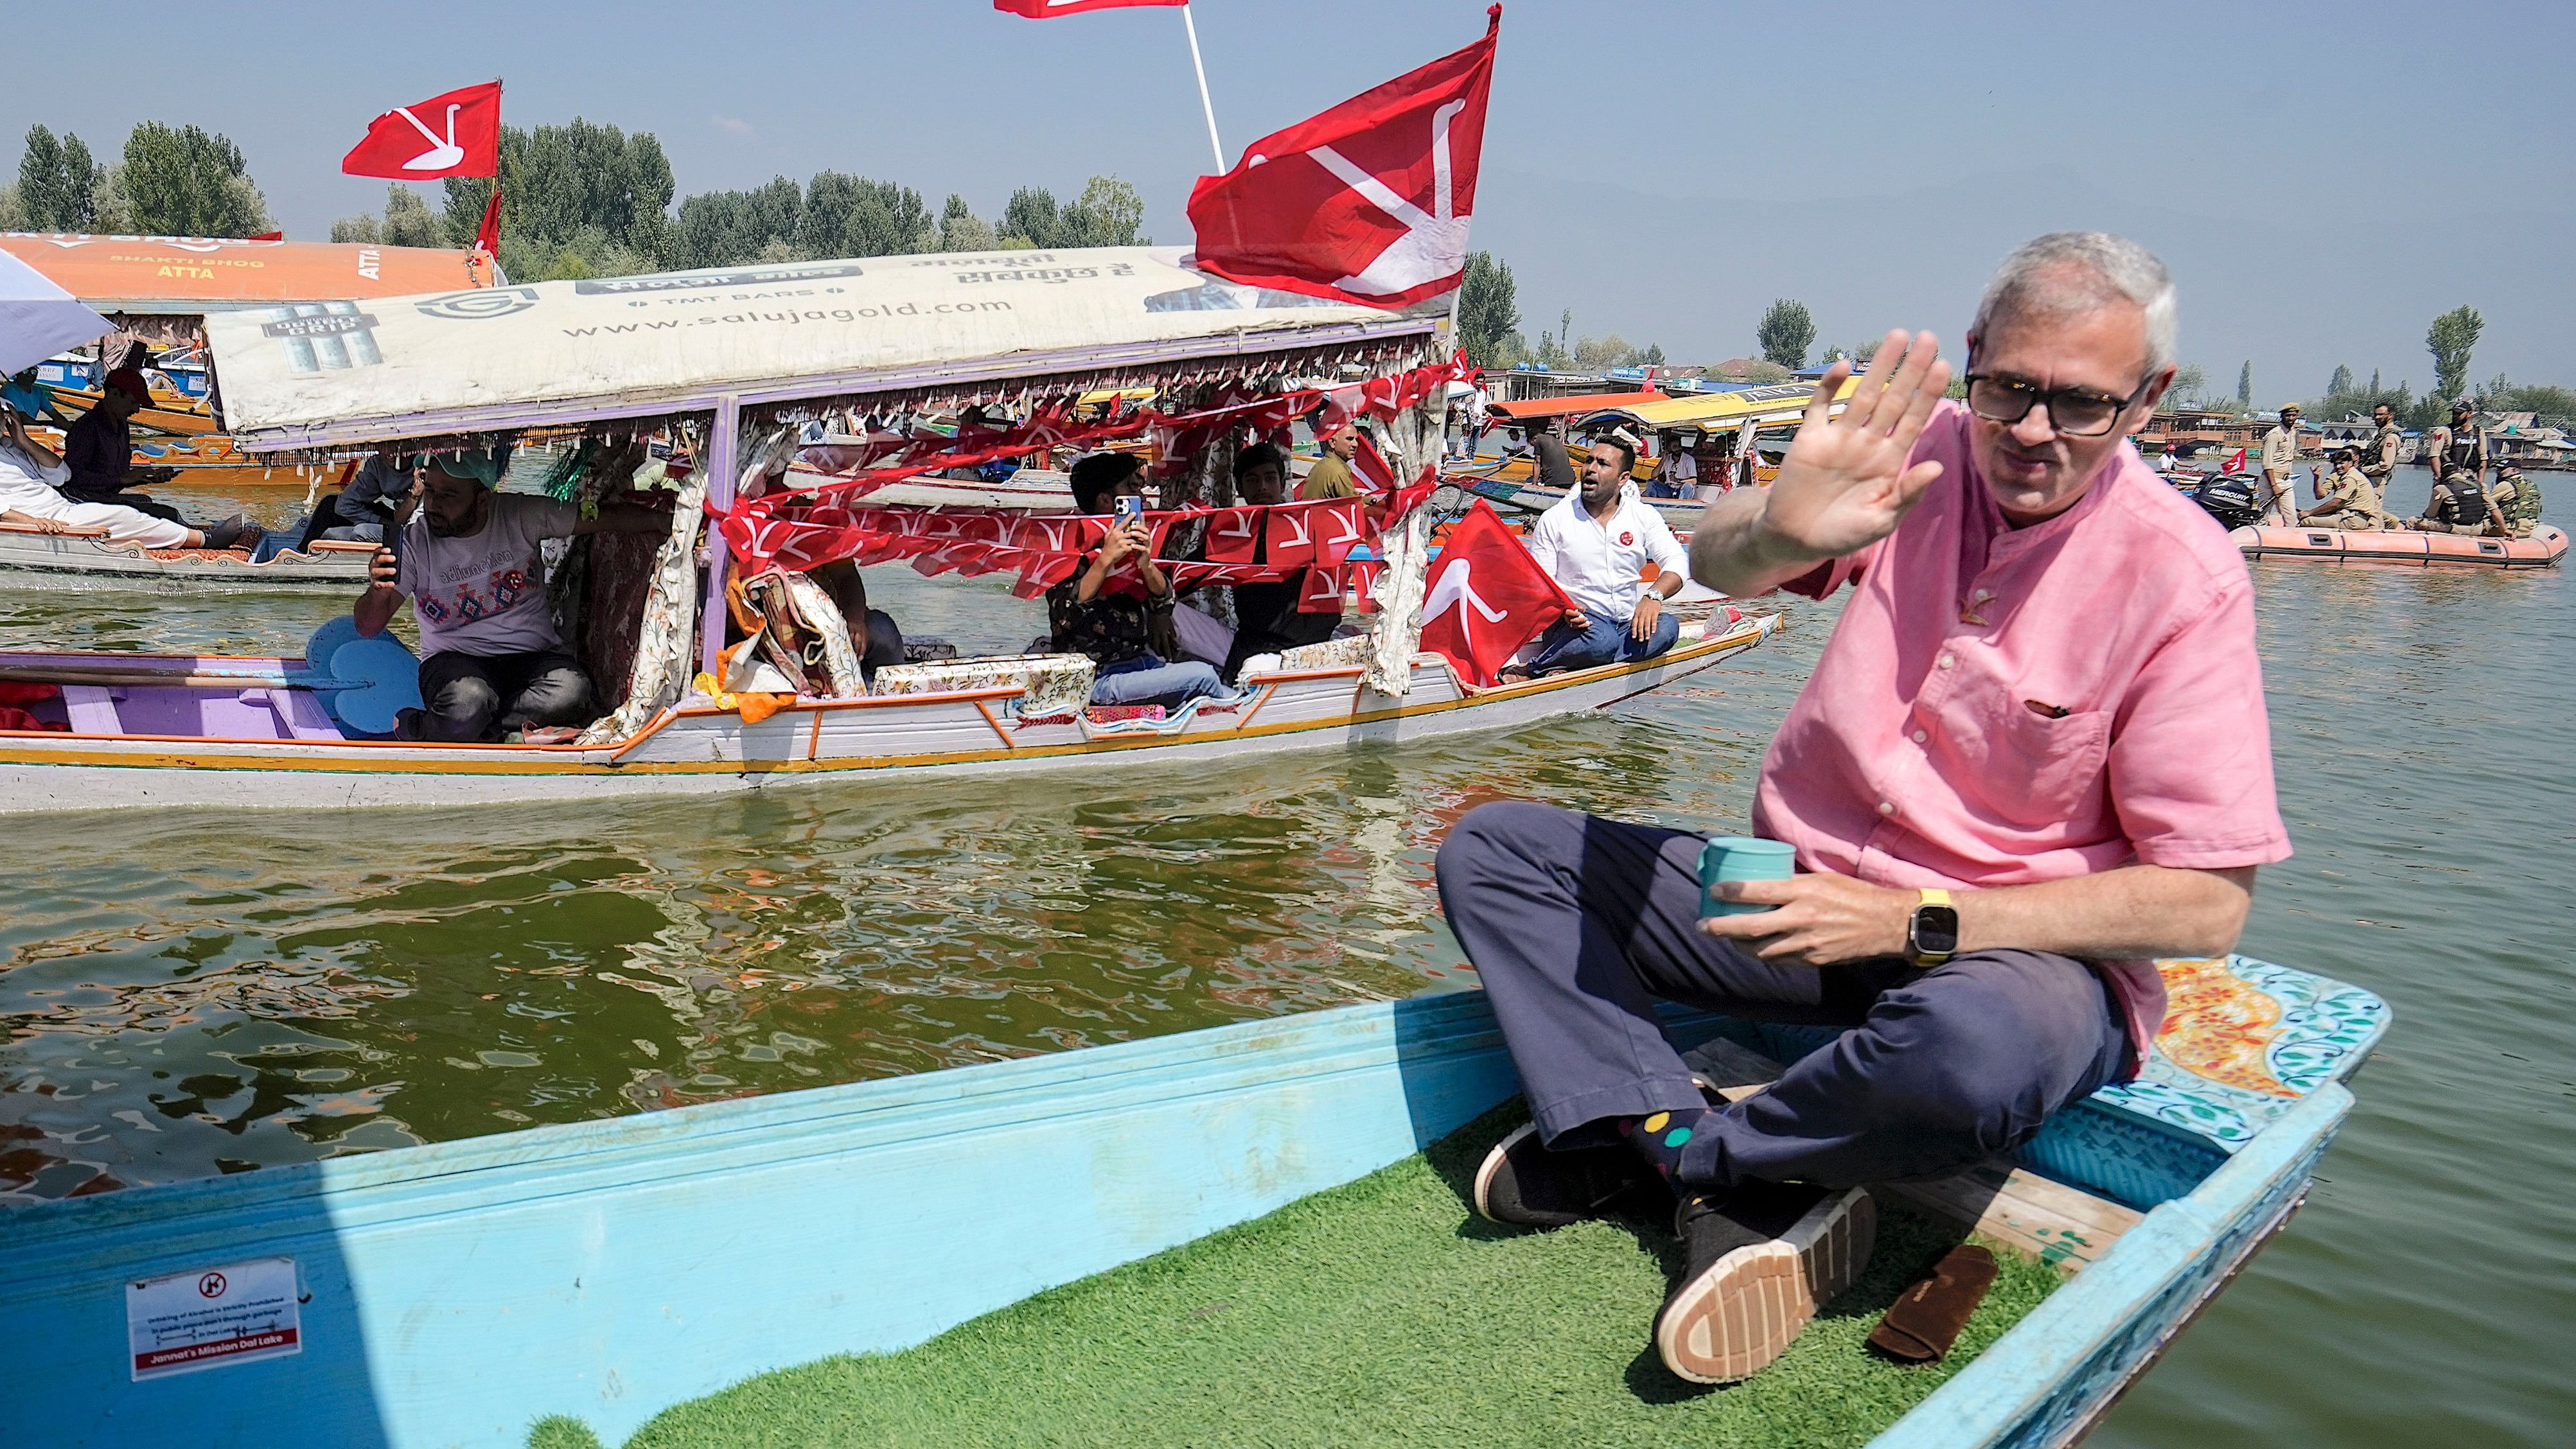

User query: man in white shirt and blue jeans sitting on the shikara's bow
[1502,432,1685,677]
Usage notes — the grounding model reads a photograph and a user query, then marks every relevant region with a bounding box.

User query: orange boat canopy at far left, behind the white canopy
[0,232,492,317]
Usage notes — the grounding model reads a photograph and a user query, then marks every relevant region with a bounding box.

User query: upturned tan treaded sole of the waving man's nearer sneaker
[1654,1186,1878,1385]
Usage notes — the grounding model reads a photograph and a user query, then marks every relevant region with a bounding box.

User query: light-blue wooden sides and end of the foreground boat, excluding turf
[0,958,2388,1449]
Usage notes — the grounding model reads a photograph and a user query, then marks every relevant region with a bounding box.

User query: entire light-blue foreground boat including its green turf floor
[0,958,2388,1449]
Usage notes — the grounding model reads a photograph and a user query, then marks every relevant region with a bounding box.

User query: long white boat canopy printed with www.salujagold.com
[206,247,1445,453]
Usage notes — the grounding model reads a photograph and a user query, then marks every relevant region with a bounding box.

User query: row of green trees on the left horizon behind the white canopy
[0,118,1149,281]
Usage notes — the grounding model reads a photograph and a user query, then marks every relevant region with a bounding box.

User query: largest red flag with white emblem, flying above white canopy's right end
[1190,5,1502,306]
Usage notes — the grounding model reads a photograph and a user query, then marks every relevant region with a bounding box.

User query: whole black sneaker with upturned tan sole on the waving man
[1654,1181,1878,1385]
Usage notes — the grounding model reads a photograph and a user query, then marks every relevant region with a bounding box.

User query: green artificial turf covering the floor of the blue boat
[543,1104,2058,1449]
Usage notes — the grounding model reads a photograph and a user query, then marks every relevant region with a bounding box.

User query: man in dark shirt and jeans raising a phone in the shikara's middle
[1046,453,1234,705]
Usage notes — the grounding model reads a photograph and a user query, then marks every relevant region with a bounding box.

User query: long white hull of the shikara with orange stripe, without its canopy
[0,615,1778,813]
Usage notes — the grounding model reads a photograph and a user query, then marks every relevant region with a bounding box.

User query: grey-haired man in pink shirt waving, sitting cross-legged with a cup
[1438,232,2290,1382]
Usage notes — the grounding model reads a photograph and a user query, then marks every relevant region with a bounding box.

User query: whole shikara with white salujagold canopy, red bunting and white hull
[0,247,1775,811]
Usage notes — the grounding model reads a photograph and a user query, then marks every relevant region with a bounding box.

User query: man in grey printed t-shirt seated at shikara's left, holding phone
[350,448,670,744]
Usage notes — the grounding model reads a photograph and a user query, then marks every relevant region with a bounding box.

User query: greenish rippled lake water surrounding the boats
[0,473,2576,1449]
